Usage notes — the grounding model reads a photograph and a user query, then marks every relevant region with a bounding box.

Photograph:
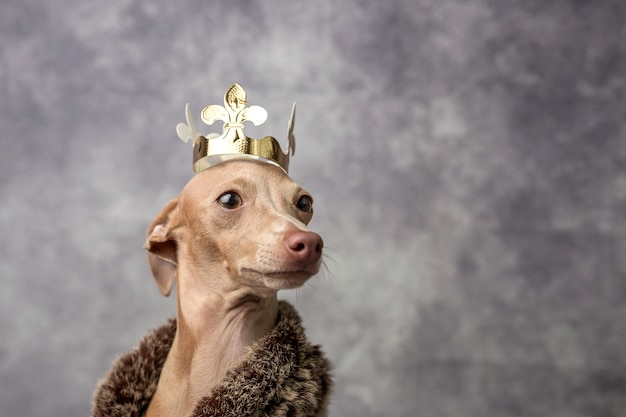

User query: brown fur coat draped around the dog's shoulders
[92,301,331,417]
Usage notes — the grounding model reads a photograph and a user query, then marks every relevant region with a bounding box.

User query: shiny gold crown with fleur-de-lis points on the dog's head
[176,83,296,174]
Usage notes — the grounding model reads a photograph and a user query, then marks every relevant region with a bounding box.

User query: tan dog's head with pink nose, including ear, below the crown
[144,160,323,295]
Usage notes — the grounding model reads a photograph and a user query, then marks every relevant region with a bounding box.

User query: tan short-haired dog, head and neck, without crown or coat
[145,160,323,417]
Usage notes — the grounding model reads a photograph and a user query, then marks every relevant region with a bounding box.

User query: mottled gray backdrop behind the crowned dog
[0,0,626,417]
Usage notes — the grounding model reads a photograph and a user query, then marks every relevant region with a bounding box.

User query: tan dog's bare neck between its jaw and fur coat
[148,266,278,416]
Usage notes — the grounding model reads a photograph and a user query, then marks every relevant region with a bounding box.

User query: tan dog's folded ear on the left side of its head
[143,198,178,297]
